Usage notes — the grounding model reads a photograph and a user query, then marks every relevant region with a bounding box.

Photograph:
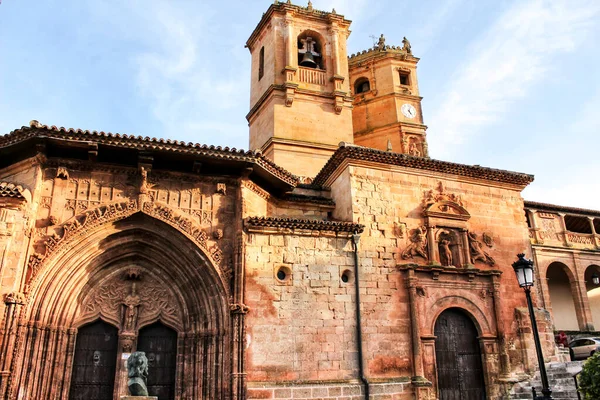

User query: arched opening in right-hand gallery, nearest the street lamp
[546,262,579,331]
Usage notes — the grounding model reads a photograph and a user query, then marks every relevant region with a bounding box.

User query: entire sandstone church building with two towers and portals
[0,2,600,400]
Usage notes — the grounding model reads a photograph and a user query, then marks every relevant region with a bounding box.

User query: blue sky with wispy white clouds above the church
[0,0,600,209]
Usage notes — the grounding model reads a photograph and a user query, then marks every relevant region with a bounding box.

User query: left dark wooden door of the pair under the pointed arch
[69,320,118,400]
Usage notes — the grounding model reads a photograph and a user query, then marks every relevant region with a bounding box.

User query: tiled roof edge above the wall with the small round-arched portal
[313,143,533,186]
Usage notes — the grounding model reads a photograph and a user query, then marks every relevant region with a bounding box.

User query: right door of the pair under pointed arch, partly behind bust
[137,322,177,400]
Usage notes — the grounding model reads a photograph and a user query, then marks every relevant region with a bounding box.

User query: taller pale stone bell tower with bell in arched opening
[246,0,353,177]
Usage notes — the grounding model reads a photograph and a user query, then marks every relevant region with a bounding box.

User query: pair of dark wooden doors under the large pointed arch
[69,320,177,400]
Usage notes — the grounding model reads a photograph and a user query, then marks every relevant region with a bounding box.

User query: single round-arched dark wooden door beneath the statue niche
[435,308,486,400]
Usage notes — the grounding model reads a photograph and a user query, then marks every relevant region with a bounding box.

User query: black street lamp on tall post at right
[513,253,552,400]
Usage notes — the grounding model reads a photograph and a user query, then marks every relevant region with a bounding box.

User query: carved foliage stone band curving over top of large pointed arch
[28,200,231,285]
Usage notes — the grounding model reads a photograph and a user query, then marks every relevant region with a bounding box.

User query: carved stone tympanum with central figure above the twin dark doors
[79,272,182,334]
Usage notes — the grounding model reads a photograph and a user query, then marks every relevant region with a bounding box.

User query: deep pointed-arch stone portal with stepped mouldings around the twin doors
[14,213,231,400]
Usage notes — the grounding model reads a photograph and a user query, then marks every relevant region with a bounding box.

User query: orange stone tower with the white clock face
[348,35,429,157]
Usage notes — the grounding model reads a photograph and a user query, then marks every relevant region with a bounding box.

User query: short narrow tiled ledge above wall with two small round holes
[245,217,365,233]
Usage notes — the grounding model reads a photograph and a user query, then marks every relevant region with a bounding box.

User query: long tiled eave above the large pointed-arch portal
[0,120,298,186]
